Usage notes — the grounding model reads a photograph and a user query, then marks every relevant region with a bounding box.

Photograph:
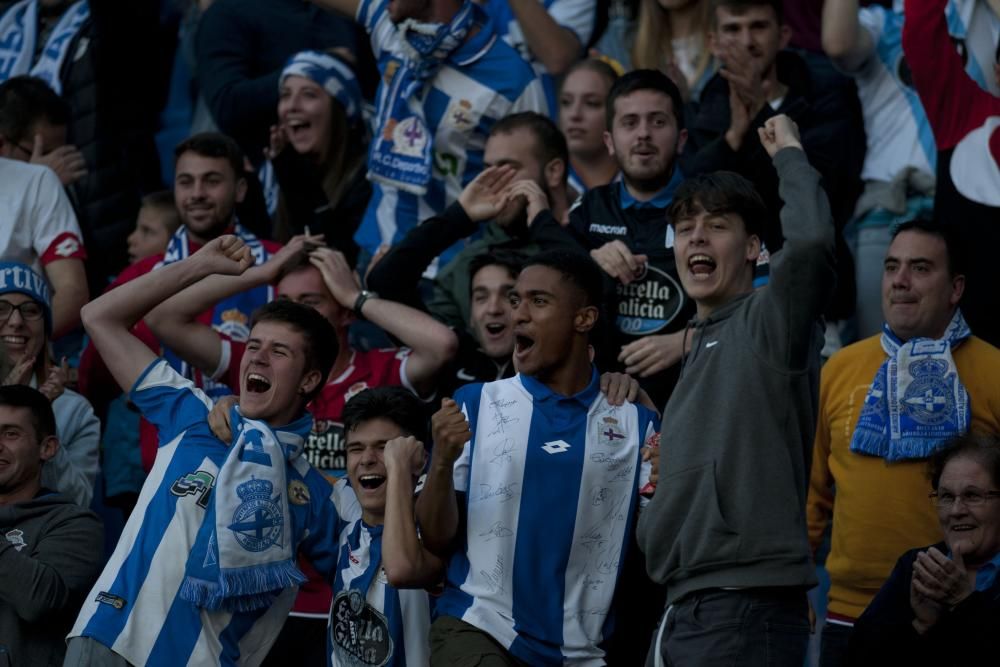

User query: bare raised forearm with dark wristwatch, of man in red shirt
[309,248,458,396]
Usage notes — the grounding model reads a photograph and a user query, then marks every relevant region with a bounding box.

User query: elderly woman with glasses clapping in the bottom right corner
[848,434,1000,667]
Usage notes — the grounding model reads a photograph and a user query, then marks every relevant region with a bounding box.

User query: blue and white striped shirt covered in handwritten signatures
[435,372,659,665]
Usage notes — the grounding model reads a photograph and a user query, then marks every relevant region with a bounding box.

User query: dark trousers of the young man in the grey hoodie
[646,588,809,667]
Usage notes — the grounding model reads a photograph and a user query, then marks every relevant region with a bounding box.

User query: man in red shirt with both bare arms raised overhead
[146,236,457,664]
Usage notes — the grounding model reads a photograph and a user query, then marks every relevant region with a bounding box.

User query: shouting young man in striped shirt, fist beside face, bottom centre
[327,387,444,667]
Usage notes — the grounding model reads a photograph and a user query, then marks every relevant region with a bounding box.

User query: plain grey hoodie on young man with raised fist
[638,148,836,604]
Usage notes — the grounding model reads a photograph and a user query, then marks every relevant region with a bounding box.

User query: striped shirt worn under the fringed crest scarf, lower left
[69,359,360,667]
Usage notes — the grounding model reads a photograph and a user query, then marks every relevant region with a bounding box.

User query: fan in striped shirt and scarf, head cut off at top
[313,0,548,272]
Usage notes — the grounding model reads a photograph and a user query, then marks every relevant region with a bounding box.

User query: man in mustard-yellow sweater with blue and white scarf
[807,219,1000,646]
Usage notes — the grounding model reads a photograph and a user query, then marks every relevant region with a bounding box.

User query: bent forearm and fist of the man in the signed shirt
[417,398,472,557]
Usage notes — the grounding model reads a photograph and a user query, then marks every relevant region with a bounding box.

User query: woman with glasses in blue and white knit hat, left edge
[0,262,101,506]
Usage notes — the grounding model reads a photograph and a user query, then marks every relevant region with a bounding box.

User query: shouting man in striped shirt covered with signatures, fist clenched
[417,252,658,665]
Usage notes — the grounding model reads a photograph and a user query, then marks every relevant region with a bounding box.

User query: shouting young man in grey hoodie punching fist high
[638,116,836,667]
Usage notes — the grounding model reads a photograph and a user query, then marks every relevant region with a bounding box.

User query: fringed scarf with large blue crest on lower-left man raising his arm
[180,406,312,612]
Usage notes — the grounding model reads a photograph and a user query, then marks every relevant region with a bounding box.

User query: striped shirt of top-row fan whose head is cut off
[354,0,548,277]
